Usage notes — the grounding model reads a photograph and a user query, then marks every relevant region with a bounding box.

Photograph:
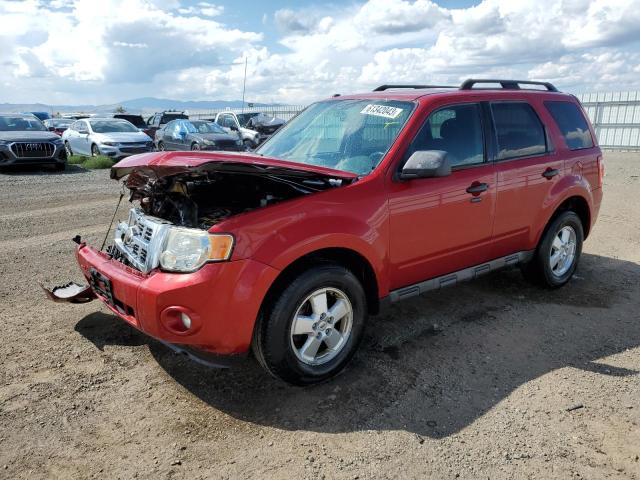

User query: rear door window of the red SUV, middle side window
[491,102,547,160]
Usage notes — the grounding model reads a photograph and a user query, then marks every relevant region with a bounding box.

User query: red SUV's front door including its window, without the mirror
[389,103,496,290]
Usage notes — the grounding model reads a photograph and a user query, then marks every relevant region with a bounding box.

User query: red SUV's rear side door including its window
[490,100,564,257]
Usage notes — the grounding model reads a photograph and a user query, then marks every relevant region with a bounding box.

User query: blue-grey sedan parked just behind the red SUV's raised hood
[155,120,245,151]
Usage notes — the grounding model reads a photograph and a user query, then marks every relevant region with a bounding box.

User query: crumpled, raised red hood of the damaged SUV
[111,151,358,180]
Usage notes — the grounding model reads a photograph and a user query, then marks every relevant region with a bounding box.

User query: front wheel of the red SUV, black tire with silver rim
[252,264,367,385]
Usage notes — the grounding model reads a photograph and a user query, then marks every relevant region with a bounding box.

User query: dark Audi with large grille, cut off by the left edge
[0,113,67,170]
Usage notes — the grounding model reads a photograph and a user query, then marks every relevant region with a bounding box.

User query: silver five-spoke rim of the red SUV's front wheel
[289,288,353,365]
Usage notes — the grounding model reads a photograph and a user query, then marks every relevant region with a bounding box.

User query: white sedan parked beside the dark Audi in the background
[62,118,153,159]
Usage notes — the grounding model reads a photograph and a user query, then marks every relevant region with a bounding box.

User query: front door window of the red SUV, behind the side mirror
[407,103,485,167]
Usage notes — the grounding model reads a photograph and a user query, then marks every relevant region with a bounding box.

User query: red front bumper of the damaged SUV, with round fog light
[76,244,279,355]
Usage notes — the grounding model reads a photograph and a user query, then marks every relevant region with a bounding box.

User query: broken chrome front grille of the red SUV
[113,208,171,273]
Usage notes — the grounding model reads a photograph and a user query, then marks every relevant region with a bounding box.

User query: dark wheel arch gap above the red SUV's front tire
[260,247,380,314]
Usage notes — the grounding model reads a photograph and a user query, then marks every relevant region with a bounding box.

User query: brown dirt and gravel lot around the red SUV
[0,153,640,479]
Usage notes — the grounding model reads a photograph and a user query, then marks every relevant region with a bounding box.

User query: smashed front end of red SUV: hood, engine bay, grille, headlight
[45,152,357,303]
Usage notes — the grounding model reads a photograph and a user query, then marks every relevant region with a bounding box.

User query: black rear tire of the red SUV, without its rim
[522,211,584,288]
